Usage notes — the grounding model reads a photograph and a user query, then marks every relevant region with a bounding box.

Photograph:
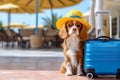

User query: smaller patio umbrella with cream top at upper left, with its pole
[0,3,41,28]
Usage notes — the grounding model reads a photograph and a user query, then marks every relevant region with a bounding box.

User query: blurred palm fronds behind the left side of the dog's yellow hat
[42,14,61,29]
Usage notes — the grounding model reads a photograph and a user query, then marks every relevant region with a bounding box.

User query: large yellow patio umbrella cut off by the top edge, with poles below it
[12,0,82,34]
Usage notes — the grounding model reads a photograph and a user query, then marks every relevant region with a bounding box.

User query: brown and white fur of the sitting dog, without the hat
[59,20,87,76]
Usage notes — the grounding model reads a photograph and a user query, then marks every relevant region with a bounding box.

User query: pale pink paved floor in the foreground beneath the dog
[0,70,88,80]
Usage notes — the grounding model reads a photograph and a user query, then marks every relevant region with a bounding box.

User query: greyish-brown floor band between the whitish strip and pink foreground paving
[0,57,63,70]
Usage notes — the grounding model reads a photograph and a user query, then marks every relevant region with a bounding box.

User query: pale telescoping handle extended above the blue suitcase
[96,10,112,38]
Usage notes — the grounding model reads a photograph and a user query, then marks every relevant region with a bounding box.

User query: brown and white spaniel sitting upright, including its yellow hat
[56,9,90,76]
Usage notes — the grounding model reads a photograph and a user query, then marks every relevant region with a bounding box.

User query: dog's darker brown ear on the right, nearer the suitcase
[79,25,88,41]
